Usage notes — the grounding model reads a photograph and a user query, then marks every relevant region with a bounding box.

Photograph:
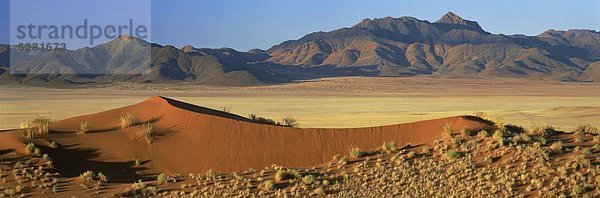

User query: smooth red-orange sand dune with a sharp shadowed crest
[42,97,488,176]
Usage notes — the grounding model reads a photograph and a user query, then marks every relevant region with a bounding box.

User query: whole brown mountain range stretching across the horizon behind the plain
[0,12,600,86]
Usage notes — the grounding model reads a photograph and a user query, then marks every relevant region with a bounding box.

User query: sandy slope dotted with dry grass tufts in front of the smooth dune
[0,114,600,197]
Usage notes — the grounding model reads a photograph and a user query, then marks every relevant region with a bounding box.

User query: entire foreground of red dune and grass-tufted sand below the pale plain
[0,97,600,197]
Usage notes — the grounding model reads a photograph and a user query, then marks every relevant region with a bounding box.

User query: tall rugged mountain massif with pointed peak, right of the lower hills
[268,12,600,80]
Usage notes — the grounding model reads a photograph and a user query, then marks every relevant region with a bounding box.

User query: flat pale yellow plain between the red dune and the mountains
[0,77,600,129]
